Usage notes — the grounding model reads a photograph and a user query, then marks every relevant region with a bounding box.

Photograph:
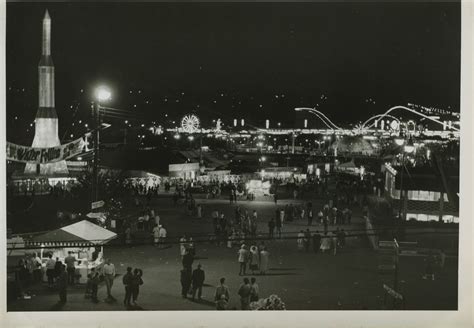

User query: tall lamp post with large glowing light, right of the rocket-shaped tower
[92,87,112,202]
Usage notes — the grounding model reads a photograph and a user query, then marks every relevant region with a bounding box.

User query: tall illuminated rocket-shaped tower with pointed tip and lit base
[25,10,68,176]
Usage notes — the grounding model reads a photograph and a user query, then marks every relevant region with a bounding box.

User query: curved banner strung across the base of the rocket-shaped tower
[7,138,86,164]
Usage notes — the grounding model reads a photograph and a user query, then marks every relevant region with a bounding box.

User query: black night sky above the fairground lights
[6,3,460,142]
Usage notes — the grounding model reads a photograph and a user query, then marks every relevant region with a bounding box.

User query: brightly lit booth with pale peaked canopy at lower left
[27,220,117,283]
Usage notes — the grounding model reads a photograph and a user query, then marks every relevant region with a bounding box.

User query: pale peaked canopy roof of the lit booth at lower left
[31,220,117,246]
